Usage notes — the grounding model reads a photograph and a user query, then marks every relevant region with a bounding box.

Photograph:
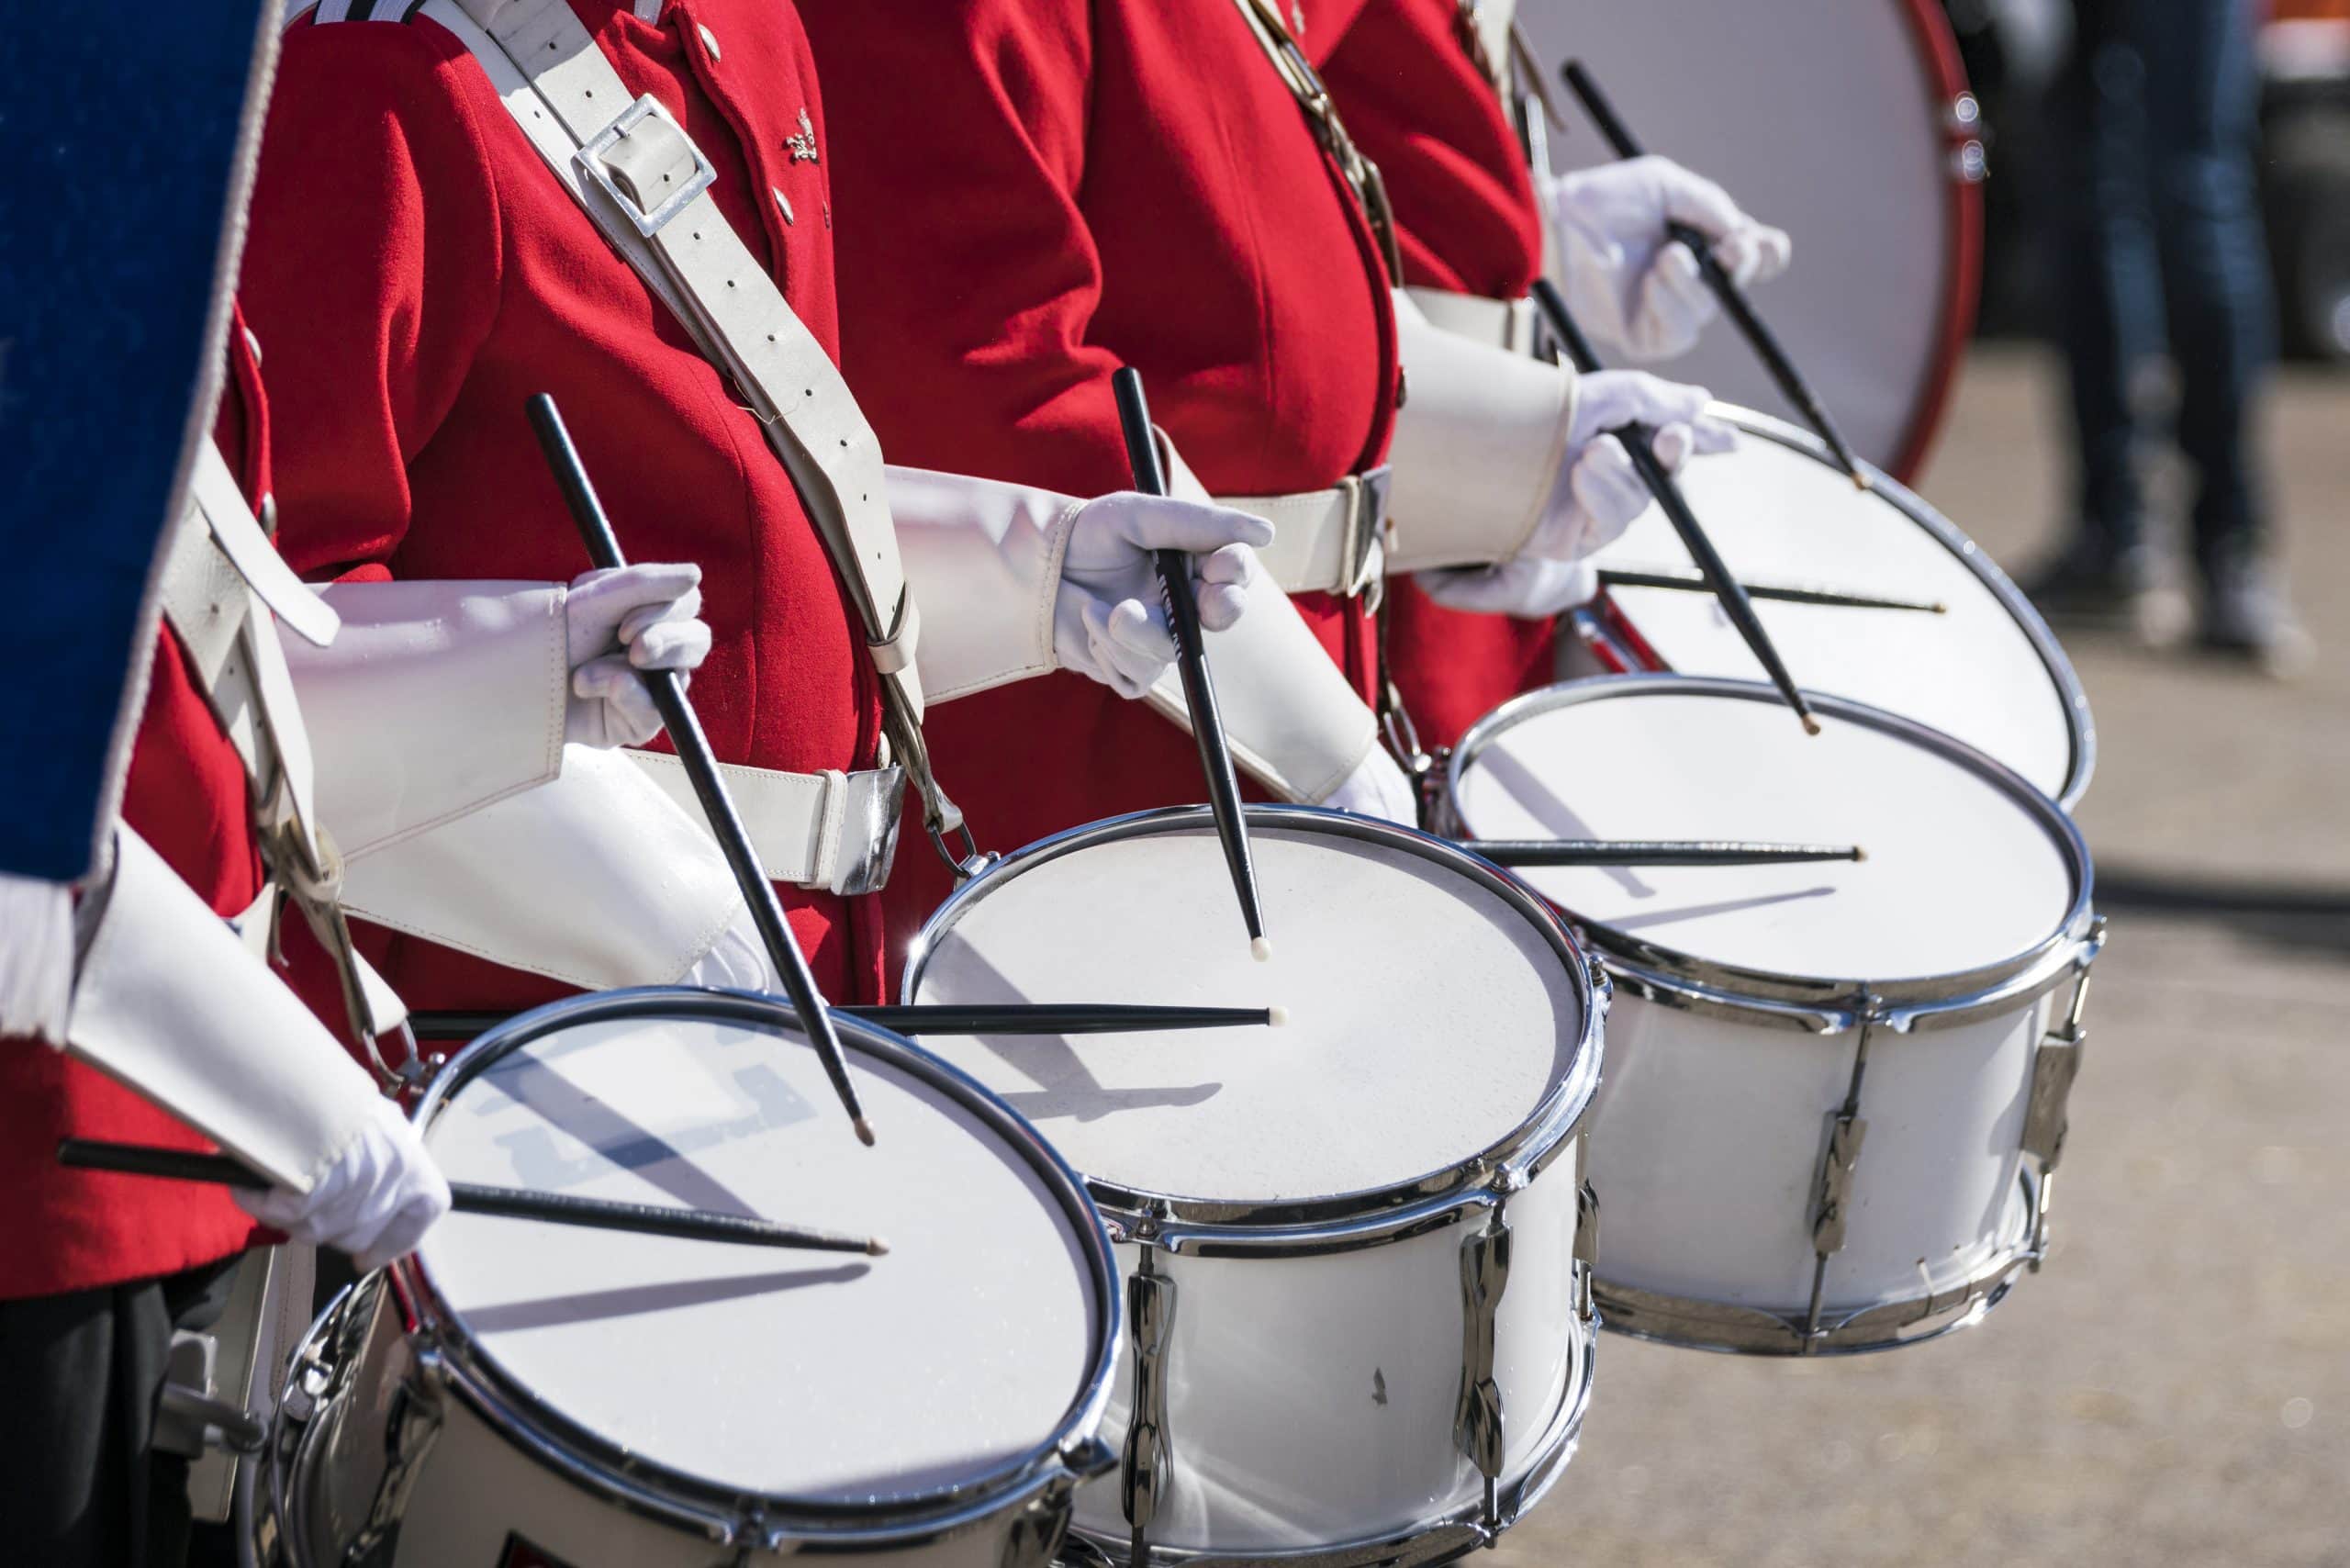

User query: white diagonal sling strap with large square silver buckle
[419,0,970,860]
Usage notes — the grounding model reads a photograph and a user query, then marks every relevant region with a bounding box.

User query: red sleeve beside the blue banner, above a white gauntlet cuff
[240,21,503,576]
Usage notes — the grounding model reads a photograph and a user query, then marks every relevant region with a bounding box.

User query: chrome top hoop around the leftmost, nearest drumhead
[386,985,1124,1544]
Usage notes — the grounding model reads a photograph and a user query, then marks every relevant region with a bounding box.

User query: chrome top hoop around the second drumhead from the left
[900,804,1607,1255]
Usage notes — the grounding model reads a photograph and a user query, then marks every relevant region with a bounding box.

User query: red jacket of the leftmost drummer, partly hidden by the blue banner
[0,321,270,1300]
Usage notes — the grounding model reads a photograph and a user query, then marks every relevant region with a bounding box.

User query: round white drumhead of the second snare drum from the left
[916,823,1582,1202]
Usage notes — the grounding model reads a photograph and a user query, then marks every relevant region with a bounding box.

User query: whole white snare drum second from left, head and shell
[907,806,1603,1563]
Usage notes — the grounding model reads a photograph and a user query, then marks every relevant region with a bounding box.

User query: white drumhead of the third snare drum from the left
[1457,682,2080,982]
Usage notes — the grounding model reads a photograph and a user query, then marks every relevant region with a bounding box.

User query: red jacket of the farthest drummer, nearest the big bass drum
[1300,0,1556,745]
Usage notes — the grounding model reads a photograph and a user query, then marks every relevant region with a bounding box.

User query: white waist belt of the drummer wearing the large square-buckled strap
[630,752,905,896]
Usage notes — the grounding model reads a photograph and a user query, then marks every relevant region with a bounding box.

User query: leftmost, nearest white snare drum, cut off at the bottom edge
[263,990,1119,1568]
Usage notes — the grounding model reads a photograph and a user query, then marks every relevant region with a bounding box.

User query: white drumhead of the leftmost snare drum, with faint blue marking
[420,1018,1109,1502]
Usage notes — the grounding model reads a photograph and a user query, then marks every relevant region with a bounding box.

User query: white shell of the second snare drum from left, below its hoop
[1076,1136,1594,1559]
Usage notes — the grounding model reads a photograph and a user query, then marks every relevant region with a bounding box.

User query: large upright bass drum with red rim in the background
[1518,0,1984,479]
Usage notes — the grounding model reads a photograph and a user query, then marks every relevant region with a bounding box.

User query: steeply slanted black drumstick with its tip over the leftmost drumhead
[526,393,874,1148]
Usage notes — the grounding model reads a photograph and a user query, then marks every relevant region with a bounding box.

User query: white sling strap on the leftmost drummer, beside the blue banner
[162,440,416,1079]
